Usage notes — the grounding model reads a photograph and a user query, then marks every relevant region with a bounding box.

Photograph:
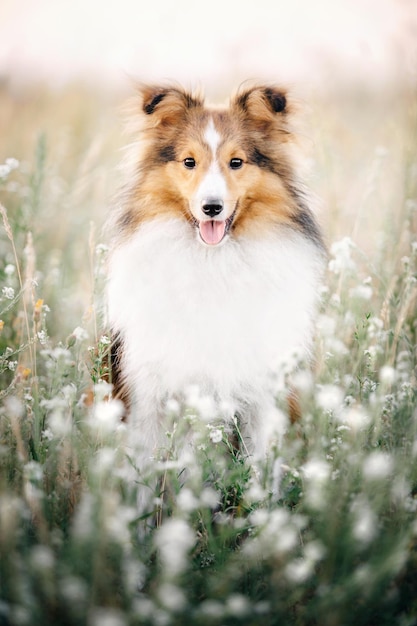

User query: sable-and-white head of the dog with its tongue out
[119,85,308,246]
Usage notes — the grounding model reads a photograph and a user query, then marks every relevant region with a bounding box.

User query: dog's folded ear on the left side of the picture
[138,84,203,126]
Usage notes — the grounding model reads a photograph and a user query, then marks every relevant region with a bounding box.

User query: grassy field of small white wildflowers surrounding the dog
[0,79,417,626]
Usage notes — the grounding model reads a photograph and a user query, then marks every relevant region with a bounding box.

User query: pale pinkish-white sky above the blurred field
[0,0,417,91]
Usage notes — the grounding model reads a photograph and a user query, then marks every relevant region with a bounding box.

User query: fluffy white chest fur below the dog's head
[108,220,322,454]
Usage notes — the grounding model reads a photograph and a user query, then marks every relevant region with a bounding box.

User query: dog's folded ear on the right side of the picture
[231,85,289,125]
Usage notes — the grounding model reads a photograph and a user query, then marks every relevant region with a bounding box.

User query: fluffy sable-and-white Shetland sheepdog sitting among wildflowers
[107,84,325,458]
